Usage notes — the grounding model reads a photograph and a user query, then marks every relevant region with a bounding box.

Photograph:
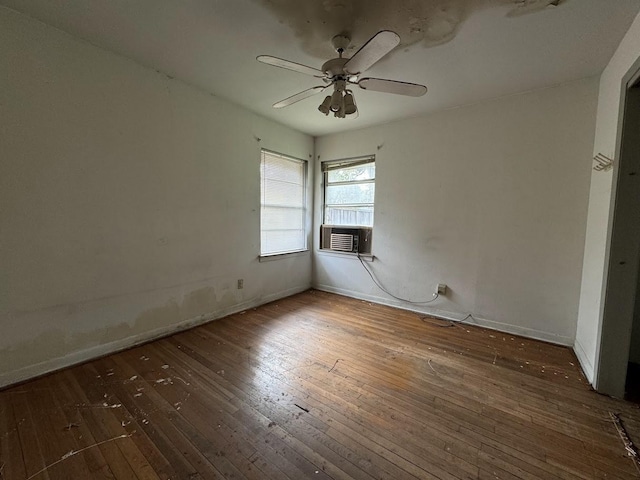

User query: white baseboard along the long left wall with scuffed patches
[0,285,311,388]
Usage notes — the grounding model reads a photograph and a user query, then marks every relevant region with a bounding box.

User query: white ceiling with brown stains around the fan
[0,0,640,135]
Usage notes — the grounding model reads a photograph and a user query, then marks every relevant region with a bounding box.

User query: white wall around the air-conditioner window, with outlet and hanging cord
[314,78,597,345]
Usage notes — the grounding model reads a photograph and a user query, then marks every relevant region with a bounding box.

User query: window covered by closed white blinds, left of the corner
[260,150,307,256]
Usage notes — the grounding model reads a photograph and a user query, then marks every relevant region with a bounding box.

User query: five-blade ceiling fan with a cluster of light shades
[256,30,427,118]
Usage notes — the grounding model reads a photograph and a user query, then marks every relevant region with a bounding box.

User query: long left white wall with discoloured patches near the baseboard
[0,8,313,386]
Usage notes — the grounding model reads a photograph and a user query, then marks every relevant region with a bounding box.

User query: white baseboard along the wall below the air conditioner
[313,285,575,347]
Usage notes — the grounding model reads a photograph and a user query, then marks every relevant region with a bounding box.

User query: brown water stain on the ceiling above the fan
[252,0,569,59]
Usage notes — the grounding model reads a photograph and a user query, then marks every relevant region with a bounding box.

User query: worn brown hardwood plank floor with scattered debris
[0,291,640,480]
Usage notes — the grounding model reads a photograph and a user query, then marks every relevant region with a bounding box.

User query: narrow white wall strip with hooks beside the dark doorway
[575,11,640,383]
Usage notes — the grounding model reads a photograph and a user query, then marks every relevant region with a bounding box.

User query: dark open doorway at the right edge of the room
[595,70,640,394]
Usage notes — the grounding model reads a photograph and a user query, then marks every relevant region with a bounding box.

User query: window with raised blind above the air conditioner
[322,157,376,227]
